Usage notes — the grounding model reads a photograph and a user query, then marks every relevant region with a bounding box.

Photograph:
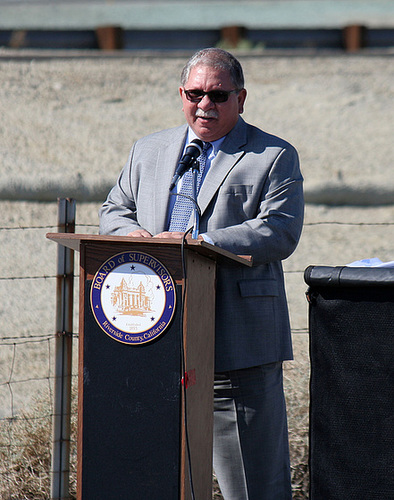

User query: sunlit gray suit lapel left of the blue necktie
[152,126,187,234]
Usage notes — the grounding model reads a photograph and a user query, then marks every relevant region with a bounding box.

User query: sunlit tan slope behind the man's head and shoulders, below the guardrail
[0,49,394,200]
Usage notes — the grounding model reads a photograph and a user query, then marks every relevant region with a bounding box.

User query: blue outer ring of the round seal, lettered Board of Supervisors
[90,251,176,345]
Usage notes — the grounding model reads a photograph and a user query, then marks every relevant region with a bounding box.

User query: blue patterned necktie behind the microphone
[168,142,211,232]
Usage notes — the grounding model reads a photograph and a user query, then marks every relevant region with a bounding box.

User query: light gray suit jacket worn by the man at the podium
[100,118,304,371]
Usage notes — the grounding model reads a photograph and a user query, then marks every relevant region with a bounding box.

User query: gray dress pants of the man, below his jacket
[213,362,292,500]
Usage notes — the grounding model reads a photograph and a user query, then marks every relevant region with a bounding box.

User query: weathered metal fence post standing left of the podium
[51,199,75,500]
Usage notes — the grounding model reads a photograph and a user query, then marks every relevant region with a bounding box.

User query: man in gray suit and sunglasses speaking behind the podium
[100,49,303,500]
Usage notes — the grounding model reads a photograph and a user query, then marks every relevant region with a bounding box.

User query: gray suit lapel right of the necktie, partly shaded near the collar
[197,117,246,219]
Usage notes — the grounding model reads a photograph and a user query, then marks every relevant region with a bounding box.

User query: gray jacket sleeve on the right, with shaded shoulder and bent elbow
[206,145,304,265]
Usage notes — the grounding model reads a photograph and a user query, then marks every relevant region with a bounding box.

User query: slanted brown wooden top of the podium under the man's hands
[46,233,253,267]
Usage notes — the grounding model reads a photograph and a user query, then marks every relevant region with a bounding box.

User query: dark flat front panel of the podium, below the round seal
[81,284,181,500]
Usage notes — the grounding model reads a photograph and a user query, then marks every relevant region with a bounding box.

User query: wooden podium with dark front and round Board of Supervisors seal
[47,233,251,500]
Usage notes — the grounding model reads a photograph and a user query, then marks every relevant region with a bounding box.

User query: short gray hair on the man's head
[181,48,245,90]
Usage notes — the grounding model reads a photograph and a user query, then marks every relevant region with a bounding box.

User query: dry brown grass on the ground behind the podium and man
[0,363,308,500]
